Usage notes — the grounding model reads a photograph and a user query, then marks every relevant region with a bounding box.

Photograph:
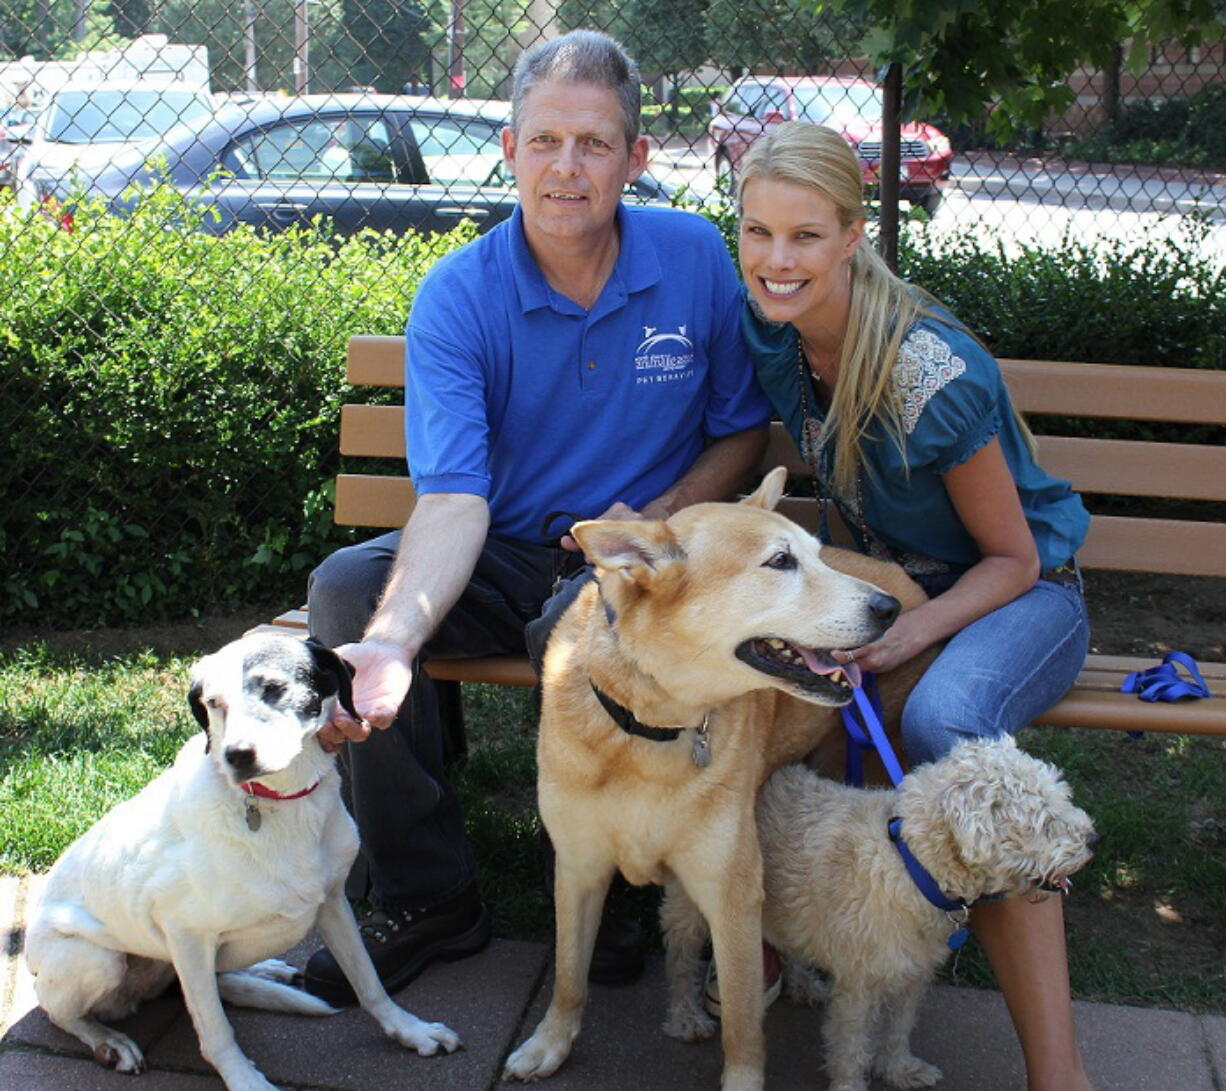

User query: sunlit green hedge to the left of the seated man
[0,192,472,628]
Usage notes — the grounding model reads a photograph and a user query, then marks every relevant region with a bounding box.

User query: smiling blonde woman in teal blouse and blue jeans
[739,121,1090,1091]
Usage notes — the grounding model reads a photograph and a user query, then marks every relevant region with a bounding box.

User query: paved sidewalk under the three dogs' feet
[0,879,1226,1091]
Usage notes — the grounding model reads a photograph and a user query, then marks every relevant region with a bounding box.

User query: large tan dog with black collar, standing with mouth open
[505,468,923,1091]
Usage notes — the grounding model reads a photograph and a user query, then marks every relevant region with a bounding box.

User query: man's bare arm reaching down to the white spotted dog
[320,493,489,749]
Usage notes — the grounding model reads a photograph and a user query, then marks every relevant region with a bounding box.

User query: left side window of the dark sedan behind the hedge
[227,116,400,183]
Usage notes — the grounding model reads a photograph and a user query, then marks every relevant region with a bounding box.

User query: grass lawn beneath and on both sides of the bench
[0,641,1226,1014]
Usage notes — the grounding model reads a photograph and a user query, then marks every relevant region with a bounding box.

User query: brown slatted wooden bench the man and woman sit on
[251,336,1226,736]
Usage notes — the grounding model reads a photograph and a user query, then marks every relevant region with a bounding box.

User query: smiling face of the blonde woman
[741,178,864,326]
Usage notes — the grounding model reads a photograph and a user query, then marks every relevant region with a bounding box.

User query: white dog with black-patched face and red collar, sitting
[26,635,460,1091]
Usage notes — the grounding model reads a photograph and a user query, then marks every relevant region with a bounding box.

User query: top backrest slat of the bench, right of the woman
[999,359,1226,424]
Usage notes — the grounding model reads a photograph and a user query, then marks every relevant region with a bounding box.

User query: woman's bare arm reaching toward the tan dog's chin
[855,439,1038,672]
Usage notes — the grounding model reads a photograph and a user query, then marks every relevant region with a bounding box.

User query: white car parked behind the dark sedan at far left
[13,83,215,206]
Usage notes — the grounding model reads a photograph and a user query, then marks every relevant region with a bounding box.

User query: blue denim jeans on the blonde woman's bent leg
[902,580,1090,765]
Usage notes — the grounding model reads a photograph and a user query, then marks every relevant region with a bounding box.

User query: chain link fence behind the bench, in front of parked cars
[0,0,1226,628]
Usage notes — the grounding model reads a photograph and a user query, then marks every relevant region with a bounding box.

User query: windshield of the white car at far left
[45,87,213,143]
